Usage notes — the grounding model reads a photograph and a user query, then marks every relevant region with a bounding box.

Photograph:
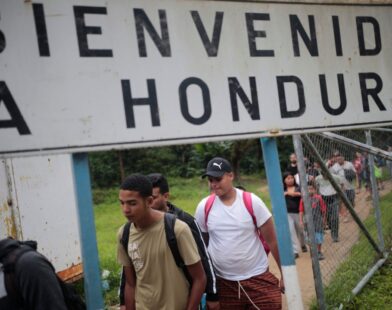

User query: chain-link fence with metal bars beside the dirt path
[294,128,392,309]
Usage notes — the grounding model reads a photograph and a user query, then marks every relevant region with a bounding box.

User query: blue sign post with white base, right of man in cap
[260,138,303,310]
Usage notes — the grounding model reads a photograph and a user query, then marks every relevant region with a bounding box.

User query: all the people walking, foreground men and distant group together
[0,148,388,310]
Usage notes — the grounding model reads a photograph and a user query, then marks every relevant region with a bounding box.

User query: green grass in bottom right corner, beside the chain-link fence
[311,193,392,309]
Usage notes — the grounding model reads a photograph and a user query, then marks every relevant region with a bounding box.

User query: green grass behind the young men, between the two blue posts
[93,176,270,305]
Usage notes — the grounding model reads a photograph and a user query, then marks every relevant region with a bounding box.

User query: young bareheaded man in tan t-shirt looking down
[117,174,206,310]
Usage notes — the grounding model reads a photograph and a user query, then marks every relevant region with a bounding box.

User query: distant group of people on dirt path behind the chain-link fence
[283,151,357,260]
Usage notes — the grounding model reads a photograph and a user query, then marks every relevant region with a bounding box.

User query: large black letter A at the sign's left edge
[0,81,31,135]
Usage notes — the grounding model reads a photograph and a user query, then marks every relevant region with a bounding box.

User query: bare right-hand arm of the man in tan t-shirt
[186,261,207,310]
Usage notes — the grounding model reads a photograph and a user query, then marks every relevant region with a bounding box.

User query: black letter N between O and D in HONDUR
[229,76,260,122]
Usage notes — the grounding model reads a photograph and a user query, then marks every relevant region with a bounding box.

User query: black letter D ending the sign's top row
[357,16,381,56]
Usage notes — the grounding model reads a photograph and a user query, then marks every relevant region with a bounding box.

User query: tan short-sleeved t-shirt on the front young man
[117,218,200,310]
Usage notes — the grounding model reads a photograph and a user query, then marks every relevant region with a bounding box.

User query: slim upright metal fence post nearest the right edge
[365,130,385,251]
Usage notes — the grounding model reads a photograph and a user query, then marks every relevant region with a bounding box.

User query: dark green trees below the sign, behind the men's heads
[89,137,293,188]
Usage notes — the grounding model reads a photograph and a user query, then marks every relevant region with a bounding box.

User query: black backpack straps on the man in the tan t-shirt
[120,213,192,286]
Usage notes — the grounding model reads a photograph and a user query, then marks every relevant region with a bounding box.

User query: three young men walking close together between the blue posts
[117,157,284,310]
